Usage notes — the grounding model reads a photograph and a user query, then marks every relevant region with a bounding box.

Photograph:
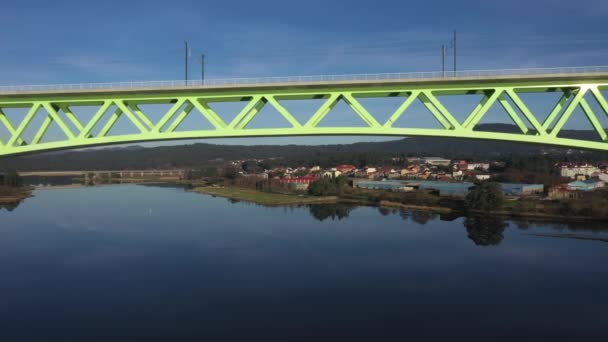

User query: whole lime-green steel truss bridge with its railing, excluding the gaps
[0,67,608,156]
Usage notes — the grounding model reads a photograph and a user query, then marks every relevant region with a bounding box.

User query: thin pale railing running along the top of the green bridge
[0,66,608,94]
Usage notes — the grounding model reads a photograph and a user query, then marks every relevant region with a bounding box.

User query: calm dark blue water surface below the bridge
[0,186,608,341]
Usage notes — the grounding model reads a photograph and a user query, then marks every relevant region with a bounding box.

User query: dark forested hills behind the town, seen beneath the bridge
[0,124,608,171]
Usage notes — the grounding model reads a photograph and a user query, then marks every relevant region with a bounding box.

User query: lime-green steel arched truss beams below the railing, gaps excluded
[0,79,608,156]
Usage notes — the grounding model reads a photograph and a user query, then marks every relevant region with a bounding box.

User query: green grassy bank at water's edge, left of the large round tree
[192,187,339,206]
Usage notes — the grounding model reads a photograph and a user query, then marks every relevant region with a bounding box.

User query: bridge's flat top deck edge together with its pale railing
[0,67,608,98]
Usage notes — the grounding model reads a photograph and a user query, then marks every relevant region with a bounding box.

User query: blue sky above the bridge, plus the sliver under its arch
[0,0,608,143]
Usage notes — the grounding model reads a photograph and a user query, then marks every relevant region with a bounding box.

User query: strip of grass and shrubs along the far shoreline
[8,179,608,223]
